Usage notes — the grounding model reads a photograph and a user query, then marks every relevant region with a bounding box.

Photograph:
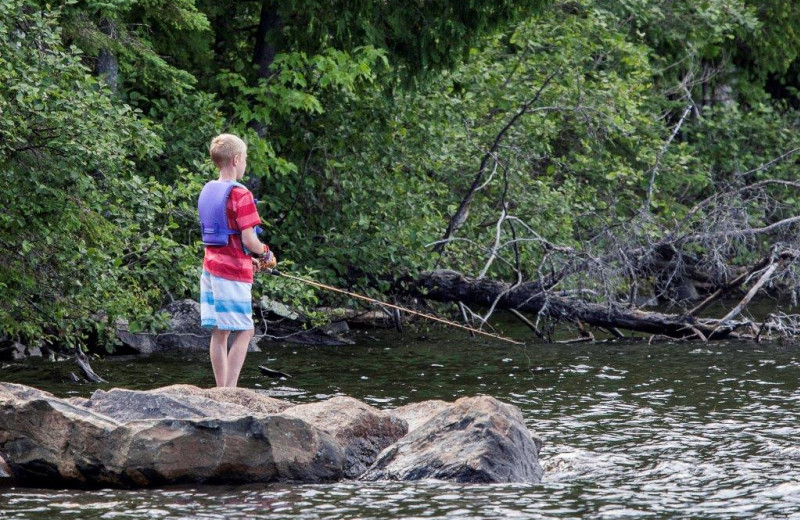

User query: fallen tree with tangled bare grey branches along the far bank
[414,143,800,341]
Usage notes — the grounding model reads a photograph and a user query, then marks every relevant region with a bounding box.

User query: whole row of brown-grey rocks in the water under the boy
[0,383,542,488]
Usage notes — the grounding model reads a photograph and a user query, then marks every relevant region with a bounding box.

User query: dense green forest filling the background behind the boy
[0,0,800,349]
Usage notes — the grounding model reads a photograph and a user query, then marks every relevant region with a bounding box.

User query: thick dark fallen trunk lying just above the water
[415,250,798,341]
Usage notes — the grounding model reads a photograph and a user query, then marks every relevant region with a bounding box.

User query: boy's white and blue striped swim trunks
[200,270,254,330]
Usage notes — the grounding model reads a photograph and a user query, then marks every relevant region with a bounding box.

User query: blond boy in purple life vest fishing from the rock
[197,134,278,388]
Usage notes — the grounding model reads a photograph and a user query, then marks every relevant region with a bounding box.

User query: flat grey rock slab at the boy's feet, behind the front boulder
[77,388,252,423]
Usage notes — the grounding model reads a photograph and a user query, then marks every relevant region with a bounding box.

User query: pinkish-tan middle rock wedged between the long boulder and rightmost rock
[283,396,408,478]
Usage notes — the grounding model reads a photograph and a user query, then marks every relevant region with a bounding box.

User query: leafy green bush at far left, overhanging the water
[0,1,197,346]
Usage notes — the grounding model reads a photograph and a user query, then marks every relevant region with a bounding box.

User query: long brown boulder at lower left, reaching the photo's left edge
[0,389,344,487]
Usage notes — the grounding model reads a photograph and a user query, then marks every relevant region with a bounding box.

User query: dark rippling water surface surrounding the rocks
[0,333,800,520]
